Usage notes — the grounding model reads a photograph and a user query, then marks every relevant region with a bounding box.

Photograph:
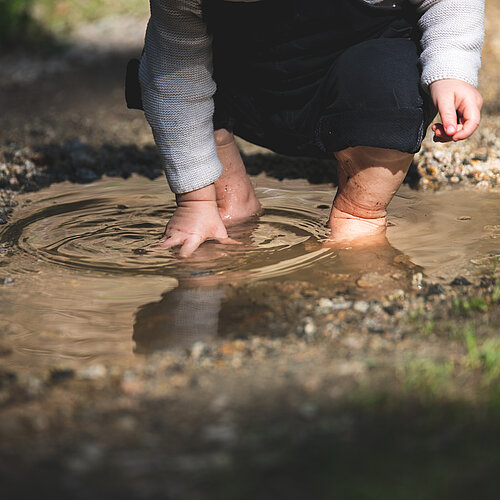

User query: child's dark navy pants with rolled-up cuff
[204,0,436,158]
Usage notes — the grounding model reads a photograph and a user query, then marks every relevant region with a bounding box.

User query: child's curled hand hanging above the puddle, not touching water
[429,78,483,142]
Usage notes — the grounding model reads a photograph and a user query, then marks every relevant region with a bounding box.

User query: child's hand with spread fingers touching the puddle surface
[158,184,239,257]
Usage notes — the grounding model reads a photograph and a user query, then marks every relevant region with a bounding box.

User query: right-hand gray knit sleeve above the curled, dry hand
[410,0,485,88]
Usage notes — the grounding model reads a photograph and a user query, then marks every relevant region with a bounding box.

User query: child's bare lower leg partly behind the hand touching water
[214,129,262,226]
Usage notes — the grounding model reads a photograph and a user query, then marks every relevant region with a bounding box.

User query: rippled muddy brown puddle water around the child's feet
[0,176,500,369]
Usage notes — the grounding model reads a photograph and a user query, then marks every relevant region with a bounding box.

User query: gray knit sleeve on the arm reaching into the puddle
[139,0,222,193]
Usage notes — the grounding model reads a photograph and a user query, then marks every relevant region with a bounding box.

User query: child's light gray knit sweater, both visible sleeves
[139,0,485,193]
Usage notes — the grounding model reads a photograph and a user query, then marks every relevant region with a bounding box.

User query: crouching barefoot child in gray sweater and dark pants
[134,0,484,257]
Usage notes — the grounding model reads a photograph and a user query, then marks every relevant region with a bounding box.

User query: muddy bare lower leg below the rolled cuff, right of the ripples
[327,146,413,247]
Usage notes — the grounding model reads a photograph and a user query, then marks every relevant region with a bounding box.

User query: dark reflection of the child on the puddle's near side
[133,235,421,353]
